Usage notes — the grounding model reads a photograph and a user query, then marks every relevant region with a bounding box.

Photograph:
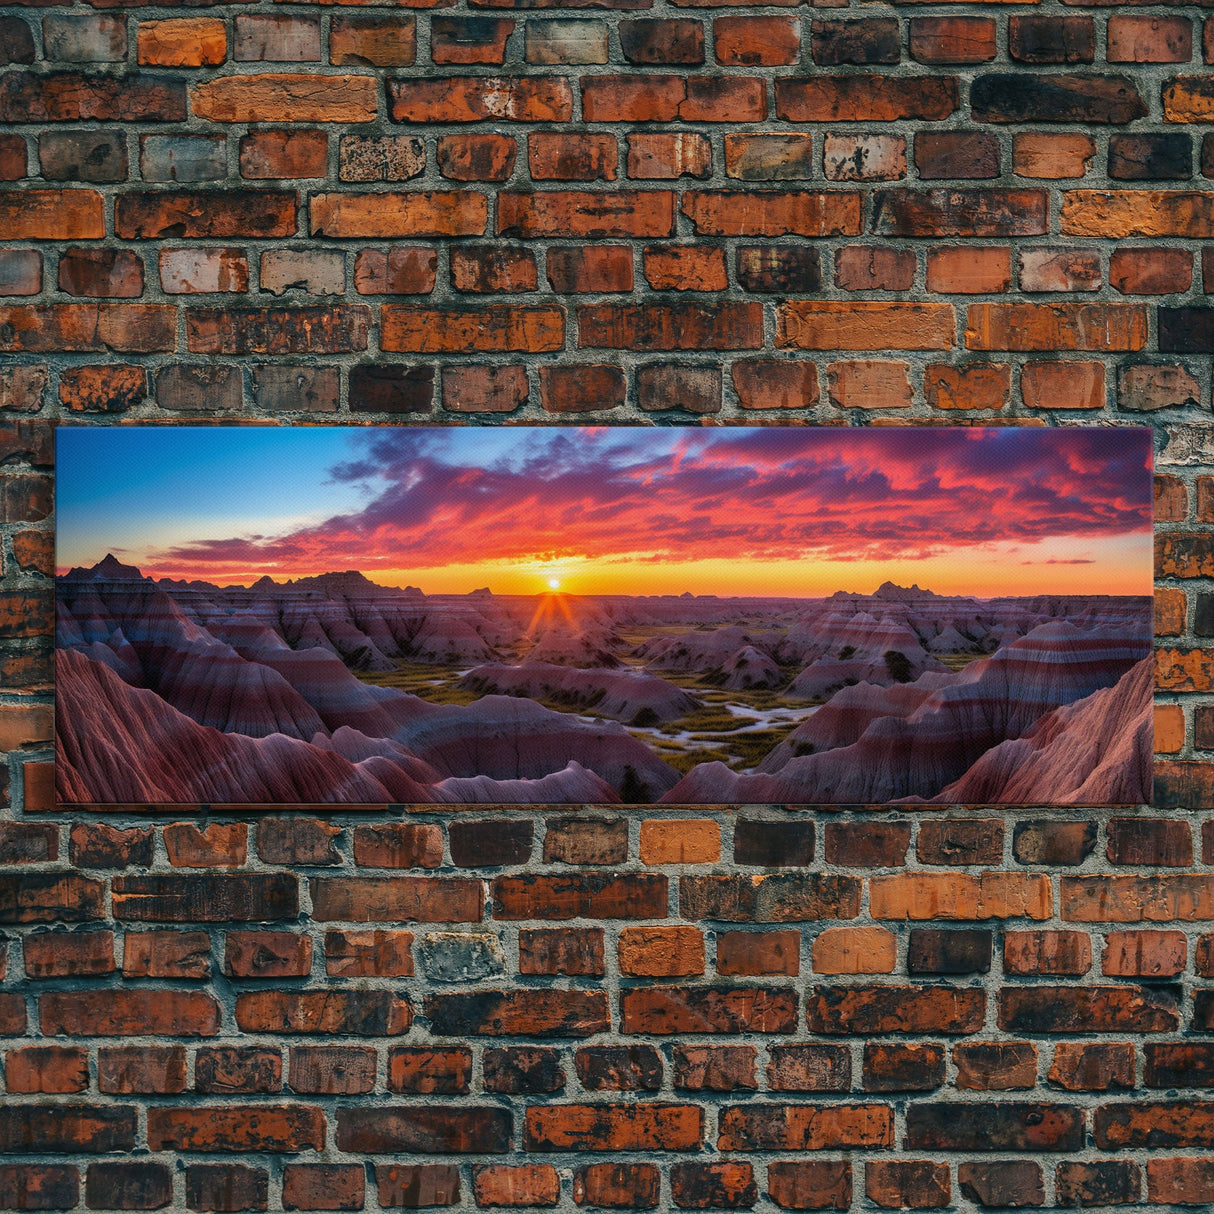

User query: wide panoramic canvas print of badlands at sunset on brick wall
[56,426,1152,806]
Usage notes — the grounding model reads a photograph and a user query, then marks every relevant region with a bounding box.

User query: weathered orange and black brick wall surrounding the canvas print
[0,0,1214,1212]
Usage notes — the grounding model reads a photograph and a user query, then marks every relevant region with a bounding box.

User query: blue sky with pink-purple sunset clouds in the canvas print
[56,426,1152,596]
